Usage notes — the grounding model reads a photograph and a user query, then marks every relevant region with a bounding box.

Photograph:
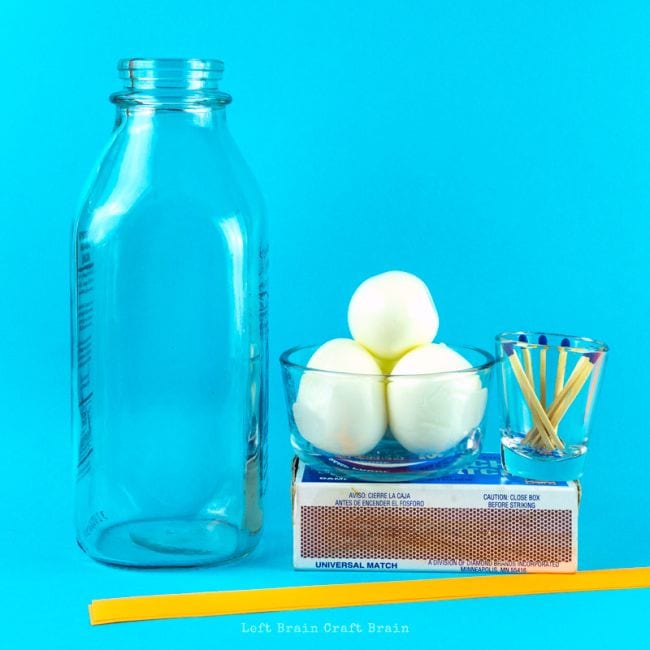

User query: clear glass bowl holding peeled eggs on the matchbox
[280,345,495,482]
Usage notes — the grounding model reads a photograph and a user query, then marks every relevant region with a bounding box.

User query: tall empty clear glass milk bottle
[72,59,267,567]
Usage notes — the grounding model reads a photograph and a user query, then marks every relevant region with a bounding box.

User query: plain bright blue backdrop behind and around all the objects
[0,0,650,649]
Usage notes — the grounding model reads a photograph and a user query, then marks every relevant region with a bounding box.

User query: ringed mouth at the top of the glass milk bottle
[117,58,223,91]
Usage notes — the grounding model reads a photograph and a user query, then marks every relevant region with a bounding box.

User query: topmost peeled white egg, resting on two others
[348,271,438,360]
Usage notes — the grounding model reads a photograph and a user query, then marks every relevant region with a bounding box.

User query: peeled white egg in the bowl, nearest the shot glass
[387,343,487,454]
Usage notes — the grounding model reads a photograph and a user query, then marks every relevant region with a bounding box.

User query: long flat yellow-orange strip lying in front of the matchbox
[89,567,650,625]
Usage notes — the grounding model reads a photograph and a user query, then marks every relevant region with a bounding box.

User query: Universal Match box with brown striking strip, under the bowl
[292,454,579,573]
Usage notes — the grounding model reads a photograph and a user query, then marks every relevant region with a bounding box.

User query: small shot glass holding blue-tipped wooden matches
[496,332,608,481]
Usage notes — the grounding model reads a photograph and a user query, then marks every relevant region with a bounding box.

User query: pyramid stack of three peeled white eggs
[293,271,487,456]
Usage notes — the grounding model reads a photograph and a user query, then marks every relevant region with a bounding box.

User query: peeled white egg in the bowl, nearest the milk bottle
[293,339,387,456]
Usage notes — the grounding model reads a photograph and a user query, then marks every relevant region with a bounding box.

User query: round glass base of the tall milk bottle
[79,519,260,568]
